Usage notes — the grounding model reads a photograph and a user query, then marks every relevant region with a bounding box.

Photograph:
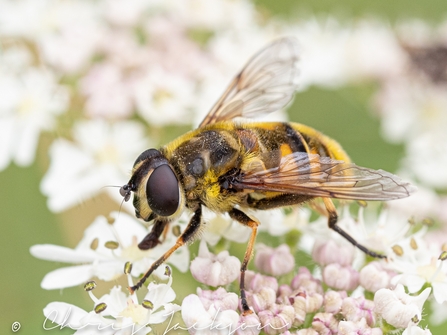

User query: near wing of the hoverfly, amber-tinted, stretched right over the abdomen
[234,152,416,200]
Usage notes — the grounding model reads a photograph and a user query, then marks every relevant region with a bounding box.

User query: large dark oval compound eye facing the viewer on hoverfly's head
[146,164,180,216]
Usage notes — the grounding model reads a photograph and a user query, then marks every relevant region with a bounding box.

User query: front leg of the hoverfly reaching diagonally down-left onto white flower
[128,205,202,294]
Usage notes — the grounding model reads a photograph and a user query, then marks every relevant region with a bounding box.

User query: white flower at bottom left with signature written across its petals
[43,277,180,335]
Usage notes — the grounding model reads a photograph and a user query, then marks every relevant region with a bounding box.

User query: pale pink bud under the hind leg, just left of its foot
[312,240,355,266]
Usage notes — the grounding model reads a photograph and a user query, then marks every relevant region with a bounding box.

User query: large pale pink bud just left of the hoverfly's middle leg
[190,240,241,287]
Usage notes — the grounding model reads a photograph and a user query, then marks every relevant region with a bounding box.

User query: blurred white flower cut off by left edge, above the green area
[0,68,68,170]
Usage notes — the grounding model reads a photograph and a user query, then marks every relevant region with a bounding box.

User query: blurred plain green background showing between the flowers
[0,0,447,335]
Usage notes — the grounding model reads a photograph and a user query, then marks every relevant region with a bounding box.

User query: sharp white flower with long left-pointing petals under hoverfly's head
[30,212,189,290]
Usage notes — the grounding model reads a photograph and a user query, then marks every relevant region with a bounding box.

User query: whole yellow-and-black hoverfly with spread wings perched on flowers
[120,38,414,314]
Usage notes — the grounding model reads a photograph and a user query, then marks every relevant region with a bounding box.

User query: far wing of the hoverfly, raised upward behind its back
[200,38,299,127]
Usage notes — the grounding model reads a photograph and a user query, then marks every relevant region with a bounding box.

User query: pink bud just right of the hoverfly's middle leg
[255,244,295,276]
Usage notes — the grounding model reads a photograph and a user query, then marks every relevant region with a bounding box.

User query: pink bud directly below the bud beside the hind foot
[323,263,359,291]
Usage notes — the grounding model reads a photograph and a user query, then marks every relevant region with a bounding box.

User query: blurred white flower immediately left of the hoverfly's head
[41,120,149,212]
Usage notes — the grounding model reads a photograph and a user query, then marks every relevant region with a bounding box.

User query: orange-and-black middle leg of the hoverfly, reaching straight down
[228,208,259,315]
